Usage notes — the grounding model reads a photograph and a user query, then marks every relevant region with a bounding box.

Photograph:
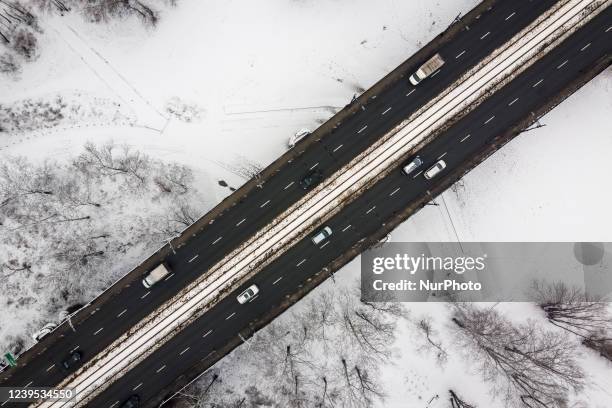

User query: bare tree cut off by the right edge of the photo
[532,281,612,361]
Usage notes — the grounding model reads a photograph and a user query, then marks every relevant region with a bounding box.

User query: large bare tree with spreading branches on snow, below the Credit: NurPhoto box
[452,303,584,408]
